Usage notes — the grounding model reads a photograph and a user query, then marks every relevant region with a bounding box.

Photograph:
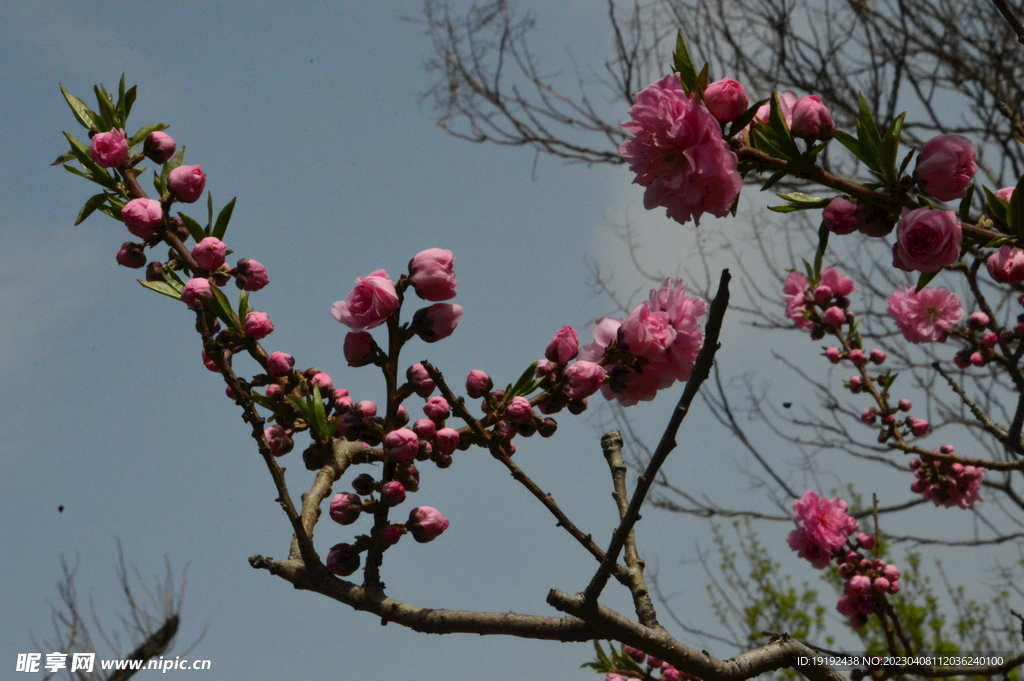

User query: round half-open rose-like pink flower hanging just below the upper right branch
[893,208,963,272]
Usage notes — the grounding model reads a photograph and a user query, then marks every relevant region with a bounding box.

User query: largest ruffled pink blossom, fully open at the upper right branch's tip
[618,74,743,223]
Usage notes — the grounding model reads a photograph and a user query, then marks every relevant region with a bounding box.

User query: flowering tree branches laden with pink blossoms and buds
[55,21,1024,681]
